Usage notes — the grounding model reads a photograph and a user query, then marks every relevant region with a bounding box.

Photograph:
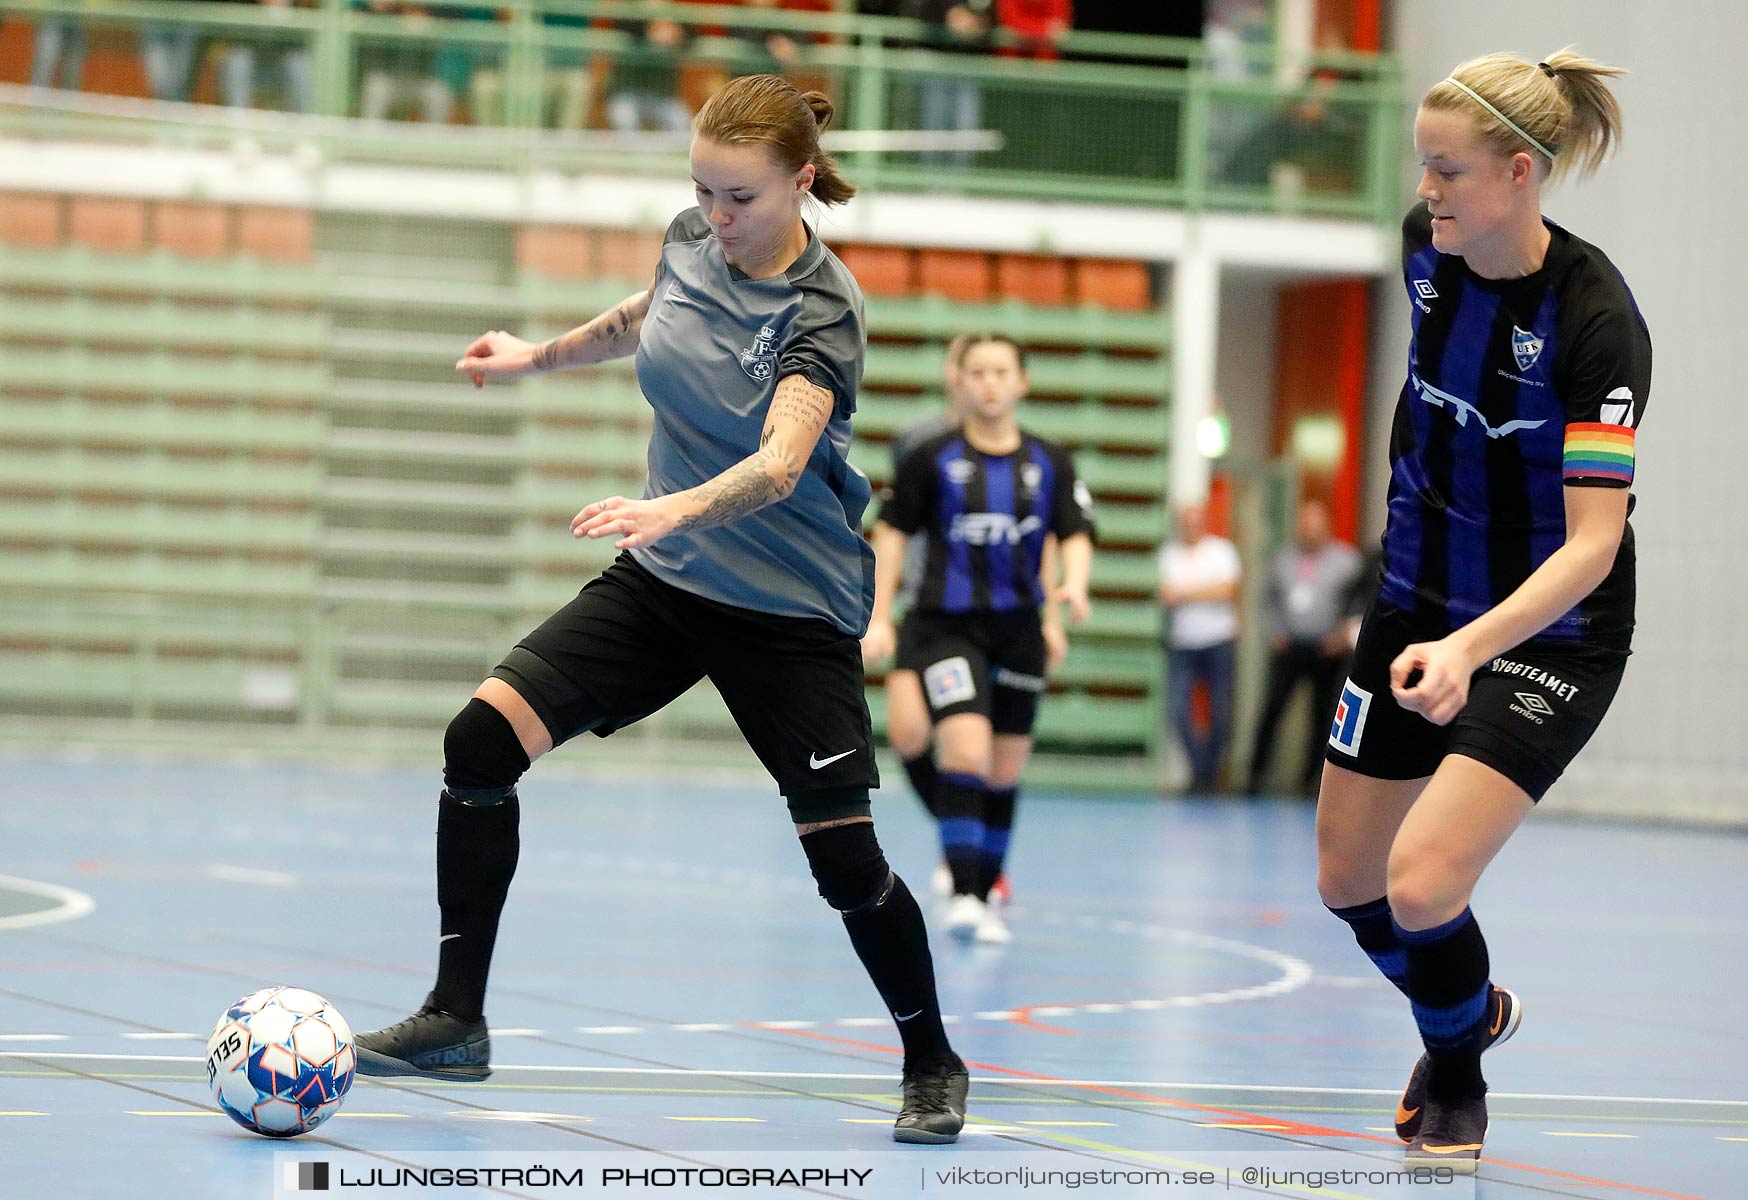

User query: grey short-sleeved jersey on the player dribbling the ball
[631,208,874,637]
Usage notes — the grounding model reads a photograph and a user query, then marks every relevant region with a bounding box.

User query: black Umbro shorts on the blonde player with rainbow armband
[1325,602,1627,799]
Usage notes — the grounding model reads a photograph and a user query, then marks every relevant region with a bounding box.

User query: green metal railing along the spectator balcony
[0,0,1402,222]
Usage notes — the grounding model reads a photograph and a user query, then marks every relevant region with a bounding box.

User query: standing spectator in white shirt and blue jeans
[1159,504,1243,792]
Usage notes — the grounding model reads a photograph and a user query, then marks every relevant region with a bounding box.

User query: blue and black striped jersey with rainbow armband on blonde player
[1379,205,1650,649]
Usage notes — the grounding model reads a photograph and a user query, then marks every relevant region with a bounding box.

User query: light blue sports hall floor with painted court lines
[0,750,1748,1200]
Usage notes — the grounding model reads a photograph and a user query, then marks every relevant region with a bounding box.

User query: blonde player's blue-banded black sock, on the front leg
[1397,908,1489,1099]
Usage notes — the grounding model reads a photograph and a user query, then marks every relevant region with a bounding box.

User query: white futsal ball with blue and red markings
[206,987,357,1137]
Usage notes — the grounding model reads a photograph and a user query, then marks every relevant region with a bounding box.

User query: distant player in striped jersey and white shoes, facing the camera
[864,334,1093,941]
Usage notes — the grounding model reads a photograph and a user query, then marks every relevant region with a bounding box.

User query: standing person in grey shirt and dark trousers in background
[1246,500,1360,796]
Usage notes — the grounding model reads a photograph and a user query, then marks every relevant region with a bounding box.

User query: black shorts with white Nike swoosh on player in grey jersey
[491,555,879,820]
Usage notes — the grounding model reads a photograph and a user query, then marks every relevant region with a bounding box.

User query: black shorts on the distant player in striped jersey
[893,609,1047,735]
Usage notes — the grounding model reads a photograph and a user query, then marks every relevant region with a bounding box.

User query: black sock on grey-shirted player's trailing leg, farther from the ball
[844,875,954,1069]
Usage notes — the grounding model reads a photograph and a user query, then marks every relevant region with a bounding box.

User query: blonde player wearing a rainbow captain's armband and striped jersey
[1318,51,1650,1170]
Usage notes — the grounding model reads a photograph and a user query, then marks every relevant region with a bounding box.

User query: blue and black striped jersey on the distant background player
[879,430,1093,612]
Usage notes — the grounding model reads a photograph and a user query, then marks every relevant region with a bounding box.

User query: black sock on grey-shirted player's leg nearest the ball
[432,791,521,1020]
